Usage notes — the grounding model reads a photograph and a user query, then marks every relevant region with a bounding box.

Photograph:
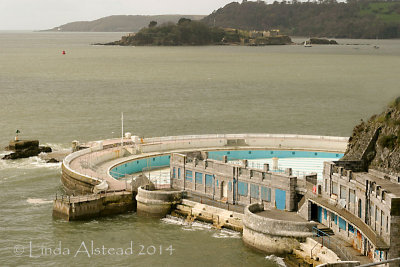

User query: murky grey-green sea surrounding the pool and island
[0,32,400,266]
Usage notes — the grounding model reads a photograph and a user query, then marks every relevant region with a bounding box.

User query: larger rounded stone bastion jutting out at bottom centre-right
[243,203,317,255]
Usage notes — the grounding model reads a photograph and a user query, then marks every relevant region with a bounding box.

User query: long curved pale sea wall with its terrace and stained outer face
[62,134,348,193]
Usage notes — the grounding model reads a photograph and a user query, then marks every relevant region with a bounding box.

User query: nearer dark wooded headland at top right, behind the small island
[202,0,400,39]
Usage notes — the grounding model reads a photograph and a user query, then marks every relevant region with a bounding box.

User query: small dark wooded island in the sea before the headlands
[105,18,292,46]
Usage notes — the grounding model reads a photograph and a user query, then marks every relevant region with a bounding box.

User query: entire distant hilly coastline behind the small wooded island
[45,0,400,39]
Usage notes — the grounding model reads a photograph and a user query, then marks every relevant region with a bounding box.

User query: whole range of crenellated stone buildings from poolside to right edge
[170,152,400,261]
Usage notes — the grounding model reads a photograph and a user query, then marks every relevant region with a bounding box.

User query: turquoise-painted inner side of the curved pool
[110,150,343,179]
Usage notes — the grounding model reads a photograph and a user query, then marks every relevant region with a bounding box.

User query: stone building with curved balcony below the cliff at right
[300,161,400,261]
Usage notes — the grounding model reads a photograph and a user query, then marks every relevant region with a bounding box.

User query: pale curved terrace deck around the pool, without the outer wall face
[64,134,347,194]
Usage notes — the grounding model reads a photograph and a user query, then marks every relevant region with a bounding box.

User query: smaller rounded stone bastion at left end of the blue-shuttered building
[136,187,184,217]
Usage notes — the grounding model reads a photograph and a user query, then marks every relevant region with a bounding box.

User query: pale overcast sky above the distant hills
[0,0,241,30]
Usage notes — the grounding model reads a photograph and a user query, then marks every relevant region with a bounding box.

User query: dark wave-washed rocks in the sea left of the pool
[2,140,52,159]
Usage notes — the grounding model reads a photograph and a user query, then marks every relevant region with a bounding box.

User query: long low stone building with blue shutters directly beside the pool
[170,153,298,211]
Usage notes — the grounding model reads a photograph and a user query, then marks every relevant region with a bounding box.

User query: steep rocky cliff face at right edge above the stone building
[342,97,400,173]
